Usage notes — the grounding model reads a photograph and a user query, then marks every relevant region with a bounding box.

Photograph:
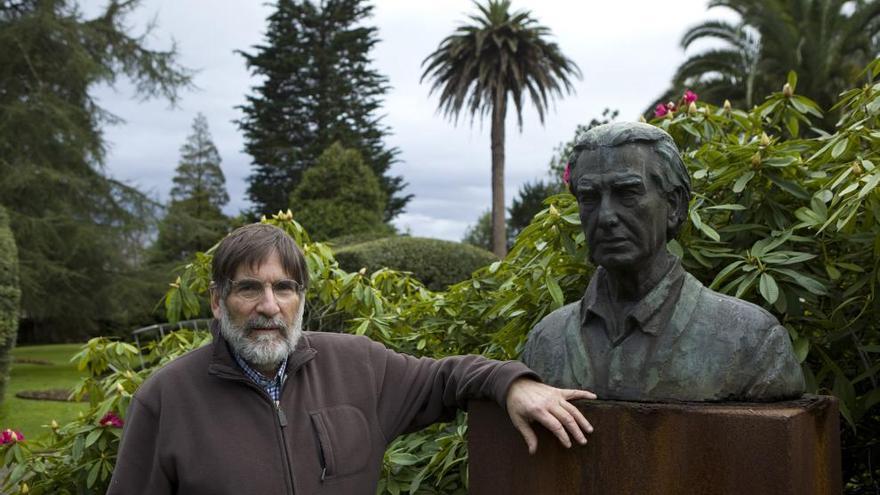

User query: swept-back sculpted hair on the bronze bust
[568,122,691,239]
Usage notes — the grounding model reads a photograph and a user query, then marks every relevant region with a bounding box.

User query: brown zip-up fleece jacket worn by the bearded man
[107,330,537,495]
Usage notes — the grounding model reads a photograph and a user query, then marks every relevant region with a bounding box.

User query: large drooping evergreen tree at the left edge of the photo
[0,0,189,338]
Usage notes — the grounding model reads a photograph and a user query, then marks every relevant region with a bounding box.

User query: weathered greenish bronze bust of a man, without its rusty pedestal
[523,123,804,401]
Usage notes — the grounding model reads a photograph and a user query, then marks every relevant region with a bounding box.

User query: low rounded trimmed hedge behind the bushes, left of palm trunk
[336,237,498,291]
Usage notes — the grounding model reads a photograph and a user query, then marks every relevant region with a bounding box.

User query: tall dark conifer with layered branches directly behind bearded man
[238,0,411,221]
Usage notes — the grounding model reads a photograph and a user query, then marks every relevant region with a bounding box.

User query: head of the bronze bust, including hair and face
[569,122,691,270]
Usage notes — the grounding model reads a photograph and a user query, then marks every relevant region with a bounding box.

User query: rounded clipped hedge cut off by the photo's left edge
[0,207,21,404]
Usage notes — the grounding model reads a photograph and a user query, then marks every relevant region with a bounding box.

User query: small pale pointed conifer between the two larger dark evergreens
[157,114,229,261]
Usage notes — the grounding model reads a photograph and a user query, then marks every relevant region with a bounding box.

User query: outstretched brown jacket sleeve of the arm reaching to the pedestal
[369,342,539,441]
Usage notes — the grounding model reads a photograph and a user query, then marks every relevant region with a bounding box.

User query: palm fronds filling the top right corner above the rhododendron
[660,0,880,126]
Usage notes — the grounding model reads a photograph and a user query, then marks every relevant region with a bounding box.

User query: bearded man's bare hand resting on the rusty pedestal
[507,378,596,454]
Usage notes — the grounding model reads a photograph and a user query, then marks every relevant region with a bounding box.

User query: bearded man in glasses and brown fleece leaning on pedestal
[108,224,595,495]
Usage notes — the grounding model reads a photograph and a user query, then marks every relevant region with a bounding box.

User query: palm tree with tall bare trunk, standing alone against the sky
[422,0,580,257]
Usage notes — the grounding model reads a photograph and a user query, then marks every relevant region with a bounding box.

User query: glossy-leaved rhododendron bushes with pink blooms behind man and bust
[0,61,880,493]
